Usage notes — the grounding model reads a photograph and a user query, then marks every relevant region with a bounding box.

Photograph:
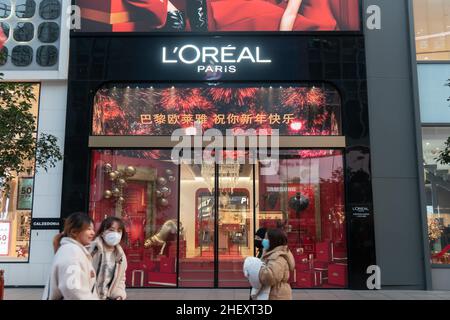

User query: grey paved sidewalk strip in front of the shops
[5,288,450,300]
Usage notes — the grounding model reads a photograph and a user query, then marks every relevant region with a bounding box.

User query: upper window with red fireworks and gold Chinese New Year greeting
[92,84,341,136]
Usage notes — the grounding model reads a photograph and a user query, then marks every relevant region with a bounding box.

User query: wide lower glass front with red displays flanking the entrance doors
[89,149,347,288]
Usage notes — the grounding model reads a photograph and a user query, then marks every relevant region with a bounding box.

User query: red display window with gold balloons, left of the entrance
[89,150,178,287]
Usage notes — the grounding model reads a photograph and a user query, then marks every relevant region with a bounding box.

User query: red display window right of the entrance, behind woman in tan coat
[256,150,347,288]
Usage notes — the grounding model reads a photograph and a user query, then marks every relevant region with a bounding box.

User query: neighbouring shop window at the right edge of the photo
[422,127,450,264]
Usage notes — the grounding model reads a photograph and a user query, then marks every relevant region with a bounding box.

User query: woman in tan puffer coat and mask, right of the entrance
[259,229,295,300]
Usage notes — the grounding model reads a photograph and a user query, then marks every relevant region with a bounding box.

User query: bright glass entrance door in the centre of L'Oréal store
[179,164,254,287]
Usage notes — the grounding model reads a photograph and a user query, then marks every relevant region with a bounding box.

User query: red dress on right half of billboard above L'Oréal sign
[208,0,338,31]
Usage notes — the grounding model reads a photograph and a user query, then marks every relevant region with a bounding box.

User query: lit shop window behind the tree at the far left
[0,84,40,262]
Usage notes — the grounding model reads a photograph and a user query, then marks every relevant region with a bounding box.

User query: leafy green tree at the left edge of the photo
[0,82,62,192]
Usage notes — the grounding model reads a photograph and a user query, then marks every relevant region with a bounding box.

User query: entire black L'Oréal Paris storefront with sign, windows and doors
[62,2,376,289]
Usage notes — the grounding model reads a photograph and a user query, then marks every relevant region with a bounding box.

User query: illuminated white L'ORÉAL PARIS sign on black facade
[162,44,272,73]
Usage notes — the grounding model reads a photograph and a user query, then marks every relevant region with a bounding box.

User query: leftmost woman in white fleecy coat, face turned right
[42,212,99,300]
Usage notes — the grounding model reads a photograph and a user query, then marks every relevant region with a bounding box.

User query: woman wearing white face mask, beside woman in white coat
[89,217,127,300]
